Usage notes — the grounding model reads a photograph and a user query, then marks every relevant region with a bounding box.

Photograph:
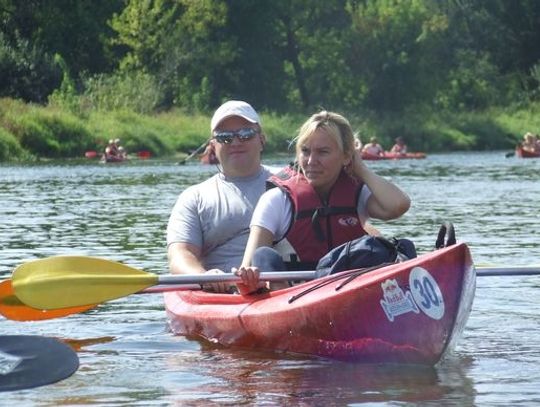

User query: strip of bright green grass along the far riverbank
[0,98,540,162]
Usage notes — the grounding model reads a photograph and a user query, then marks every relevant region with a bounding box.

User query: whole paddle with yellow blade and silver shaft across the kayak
[12,256,540,310]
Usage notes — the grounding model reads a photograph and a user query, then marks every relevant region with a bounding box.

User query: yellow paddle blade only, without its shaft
[12,256,158,309]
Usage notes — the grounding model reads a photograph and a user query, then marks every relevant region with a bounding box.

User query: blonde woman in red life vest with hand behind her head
[238,111,410,290]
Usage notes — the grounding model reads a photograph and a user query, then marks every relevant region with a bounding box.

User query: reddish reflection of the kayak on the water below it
[162,349,474,406]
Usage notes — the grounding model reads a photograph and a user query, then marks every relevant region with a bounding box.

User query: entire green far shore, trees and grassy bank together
[4,0,540,162]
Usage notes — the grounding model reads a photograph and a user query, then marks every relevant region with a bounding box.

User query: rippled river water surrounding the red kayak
[0,152,540,406]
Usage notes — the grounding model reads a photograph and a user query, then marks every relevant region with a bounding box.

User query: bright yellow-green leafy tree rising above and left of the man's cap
[112,0,235,111]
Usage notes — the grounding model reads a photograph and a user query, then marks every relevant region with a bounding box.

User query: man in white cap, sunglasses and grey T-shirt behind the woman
[167,100,271,292]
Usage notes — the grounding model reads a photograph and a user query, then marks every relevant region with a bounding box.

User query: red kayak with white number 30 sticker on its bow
[164,243,476,365]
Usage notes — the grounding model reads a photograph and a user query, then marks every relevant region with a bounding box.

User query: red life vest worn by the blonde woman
[268,167,367,270]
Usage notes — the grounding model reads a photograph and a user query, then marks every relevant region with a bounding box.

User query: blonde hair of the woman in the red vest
[296,110,354,157]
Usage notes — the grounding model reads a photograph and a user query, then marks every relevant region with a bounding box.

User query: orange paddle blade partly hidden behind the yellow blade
[0,280,97,321]
